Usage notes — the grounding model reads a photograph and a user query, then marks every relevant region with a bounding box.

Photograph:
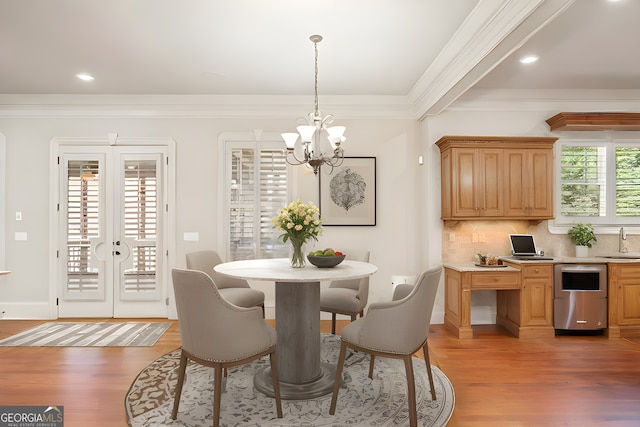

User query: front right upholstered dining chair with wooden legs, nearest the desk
[329,266,442,427]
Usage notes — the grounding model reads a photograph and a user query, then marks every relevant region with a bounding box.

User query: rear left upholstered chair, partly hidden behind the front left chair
[187,251,264,317]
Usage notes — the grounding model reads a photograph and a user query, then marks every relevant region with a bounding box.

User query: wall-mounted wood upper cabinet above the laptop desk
[436,136,557,220]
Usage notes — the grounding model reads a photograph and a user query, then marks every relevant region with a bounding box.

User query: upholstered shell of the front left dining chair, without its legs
[172,269,275,362]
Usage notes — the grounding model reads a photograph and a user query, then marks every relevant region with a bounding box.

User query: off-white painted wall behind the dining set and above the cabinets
[5,91,640,323]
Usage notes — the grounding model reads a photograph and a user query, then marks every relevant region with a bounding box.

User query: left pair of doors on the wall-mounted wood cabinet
[450,148,504,218]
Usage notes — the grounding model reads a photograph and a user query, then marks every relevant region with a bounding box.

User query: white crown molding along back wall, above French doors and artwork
[0,95,416,120]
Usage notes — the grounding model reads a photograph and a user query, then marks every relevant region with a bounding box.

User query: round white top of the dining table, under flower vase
[214,258,378,282]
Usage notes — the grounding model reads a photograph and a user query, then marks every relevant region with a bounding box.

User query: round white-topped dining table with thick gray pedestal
[214,258,377,400]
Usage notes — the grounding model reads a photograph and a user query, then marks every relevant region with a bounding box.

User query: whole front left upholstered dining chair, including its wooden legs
[171,269,282,427]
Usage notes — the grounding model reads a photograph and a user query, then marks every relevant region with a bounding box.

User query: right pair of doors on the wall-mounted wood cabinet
[504,149,553,219]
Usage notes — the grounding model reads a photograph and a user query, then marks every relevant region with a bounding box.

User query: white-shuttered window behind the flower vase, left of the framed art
[225,141,289,261]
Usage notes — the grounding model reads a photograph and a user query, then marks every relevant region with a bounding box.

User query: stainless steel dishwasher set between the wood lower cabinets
[553,264,607,331]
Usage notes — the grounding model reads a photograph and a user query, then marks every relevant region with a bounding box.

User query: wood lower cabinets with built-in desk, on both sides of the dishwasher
[444,261,640,338]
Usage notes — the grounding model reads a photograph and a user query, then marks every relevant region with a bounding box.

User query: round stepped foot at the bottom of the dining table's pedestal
[253,363,336,400]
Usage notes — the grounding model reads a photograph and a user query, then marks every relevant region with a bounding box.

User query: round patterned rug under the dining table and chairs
[125,334,455,427]
